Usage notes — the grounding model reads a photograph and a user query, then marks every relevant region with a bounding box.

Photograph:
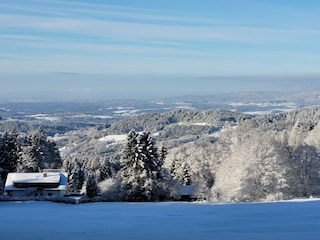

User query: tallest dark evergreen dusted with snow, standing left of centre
[121,131,162,201]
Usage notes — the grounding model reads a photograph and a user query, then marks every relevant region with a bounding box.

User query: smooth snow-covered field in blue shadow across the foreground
[0,200,320,240]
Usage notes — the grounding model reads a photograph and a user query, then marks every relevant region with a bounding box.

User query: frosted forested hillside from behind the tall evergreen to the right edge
[55,108,320,202]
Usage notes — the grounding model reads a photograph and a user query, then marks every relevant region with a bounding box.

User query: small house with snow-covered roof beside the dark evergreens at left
[4,172,68,197]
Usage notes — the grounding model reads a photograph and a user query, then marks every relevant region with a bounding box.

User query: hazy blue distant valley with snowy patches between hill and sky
[0,91,320,136]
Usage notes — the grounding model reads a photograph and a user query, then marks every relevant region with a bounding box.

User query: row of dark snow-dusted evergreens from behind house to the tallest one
[0,129,191,201]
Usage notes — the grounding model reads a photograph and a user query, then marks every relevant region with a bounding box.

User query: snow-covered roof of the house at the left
[5,172,68,191]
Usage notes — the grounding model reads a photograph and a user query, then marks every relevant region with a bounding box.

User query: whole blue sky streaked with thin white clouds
[0,0,320,98]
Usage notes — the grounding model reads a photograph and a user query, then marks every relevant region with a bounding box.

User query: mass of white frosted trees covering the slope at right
[168,108,320,201]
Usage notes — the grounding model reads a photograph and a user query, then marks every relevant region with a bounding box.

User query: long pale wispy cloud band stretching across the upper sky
[0,14,319,44]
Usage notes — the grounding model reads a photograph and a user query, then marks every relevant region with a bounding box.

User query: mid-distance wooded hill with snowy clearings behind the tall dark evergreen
[54,109,253,157]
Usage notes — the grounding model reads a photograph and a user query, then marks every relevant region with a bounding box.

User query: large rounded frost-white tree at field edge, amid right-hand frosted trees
[242,136,288,201]
